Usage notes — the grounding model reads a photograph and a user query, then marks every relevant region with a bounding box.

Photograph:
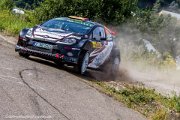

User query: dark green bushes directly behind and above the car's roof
[35,0,137,23]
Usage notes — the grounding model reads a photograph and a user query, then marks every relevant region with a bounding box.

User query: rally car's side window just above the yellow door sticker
[93,27,106,40]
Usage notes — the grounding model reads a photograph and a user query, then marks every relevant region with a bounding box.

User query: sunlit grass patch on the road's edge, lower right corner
[92,81,180,120]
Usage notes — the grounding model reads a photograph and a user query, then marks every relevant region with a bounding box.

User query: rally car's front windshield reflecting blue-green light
[41,19,93,34]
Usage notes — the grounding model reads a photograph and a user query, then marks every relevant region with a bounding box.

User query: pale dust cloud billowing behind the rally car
[91,25,180,94]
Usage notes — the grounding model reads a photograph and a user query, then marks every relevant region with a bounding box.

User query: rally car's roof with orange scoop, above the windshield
[54,16,103,27]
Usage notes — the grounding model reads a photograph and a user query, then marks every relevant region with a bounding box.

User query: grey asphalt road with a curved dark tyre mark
[0,35,145,120]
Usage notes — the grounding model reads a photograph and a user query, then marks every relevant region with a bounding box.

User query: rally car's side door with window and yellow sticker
[88,27,113,69]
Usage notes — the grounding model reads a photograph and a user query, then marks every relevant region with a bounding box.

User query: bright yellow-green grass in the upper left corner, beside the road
[0,0,35,36]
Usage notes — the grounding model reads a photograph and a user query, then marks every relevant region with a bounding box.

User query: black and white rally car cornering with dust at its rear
[15,16,120,75]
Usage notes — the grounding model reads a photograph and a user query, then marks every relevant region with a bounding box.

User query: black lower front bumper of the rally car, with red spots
[15,45,78,64]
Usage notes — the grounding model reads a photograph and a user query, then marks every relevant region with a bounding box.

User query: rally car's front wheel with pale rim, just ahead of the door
[75,51,90,75]
